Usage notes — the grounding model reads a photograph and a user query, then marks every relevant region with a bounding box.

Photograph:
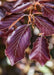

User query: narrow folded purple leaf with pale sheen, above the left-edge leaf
[11,2,32,13]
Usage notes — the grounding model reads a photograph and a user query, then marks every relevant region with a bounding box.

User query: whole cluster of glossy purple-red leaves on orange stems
[0,0,54,65]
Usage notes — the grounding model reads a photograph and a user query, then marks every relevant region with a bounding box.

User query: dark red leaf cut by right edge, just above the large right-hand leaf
[42,6,54,22]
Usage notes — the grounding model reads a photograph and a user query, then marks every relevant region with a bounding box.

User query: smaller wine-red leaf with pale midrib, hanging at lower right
[29,37,50,65]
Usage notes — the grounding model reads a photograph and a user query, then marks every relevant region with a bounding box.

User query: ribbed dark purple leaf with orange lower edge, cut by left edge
[0,14,24,30]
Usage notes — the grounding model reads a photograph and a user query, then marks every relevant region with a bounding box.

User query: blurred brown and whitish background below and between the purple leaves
[0,0,54,75]
